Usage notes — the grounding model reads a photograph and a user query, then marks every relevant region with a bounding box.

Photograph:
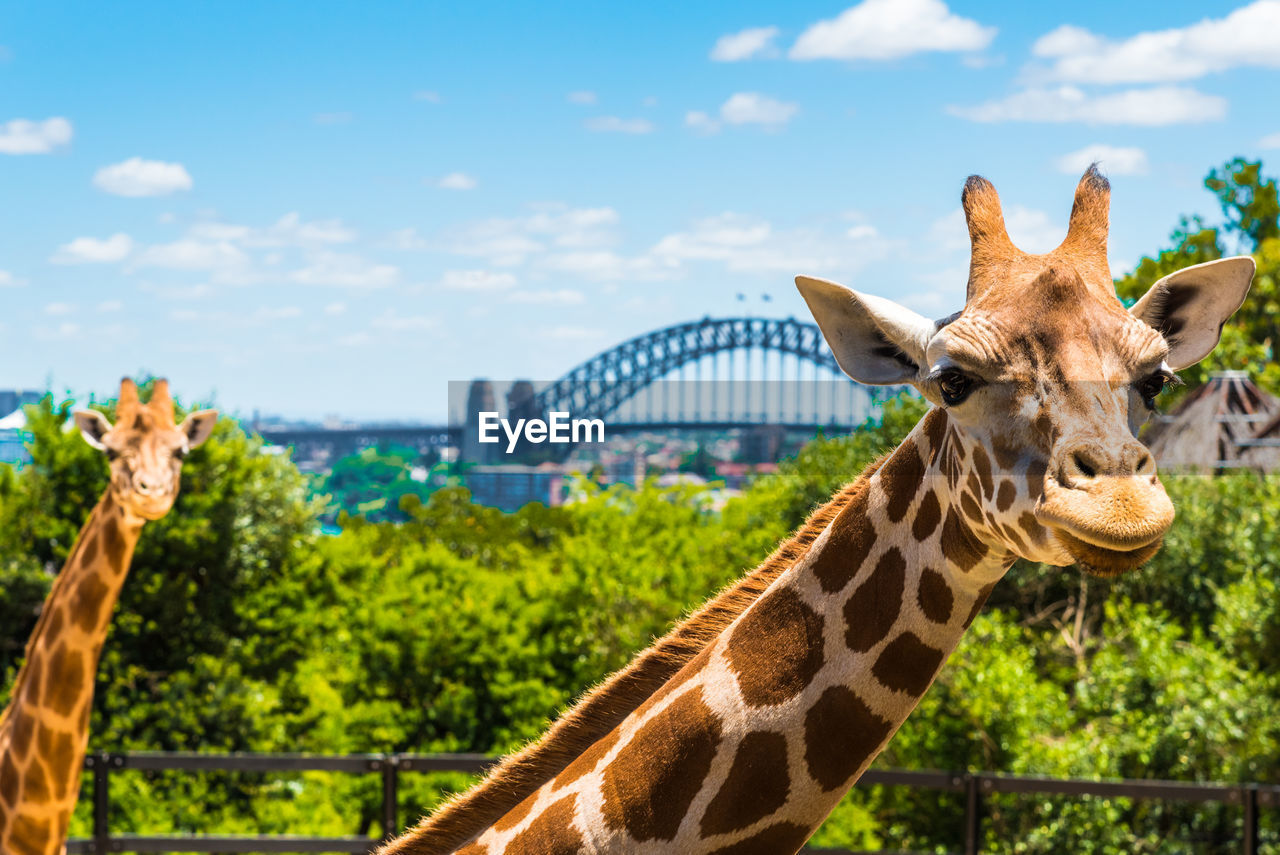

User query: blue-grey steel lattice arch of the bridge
[527,317,900,430]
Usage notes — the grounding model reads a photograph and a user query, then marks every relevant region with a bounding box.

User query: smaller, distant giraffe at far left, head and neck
[0,378,218,855]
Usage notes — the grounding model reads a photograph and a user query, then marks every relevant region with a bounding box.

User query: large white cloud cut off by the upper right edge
[1030,0,1280,83]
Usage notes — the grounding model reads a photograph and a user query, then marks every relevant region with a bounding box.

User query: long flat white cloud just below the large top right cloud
[947,86,1226,127]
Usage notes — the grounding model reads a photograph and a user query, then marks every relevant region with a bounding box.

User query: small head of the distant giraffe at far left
[76,378,218,520]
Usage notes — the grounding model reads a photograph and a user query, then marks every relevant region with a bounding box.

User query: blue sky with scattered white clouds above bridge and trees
[0,0,1280,419]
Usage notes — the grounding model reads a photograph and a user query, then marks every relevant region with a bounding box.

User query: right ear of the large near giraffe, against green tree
[1129,255,1254,371]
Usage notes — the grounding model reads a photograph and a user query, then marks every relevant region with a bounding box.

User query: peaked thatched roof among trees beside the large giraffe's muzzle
[1144,371,1280,471]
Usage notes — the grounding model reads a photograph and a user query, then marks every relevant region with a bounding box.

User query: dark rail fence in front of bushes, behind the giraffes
[67,751,1280,855]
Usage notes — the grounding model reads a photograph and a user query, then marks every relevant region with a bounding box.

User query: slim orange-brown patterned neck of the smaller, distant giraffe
[0,491,142,855]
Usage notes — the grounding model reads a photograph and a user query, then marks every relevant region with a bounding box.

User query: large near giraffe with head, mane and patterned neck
[380,166,1253,855]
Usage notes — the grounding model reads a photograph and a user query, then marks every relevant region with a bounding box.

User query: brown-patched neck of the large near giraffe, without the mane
[445,411,1012,855]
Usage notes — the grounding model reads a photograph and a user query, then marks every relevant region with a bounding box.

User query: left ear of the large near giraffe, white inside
[796,276,937,385]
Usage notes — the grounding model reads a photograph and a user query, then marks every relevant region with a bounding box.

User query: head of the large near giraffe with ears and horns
[796,166,1253,575]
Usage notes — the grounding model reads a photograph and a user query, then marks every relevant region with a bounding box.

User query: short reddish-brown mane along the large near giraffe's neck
[376,457,884,855]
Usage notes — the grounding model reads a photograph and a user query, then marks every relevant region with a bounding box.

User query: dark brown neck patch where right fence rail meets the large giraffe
[804,686,892,791]
